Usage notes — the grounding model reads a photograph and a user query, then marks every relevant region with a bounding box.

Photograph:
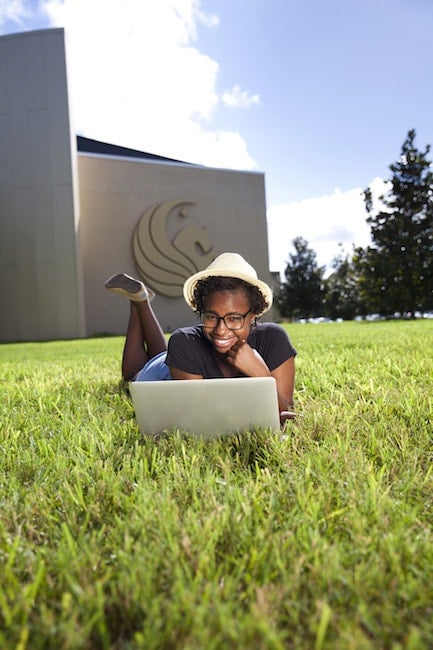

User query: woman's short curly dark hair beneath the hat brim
[192,275,269,314]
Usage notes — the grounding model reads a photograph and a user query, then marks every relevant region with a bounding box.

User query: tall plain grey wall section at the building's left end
[0,29,85,341]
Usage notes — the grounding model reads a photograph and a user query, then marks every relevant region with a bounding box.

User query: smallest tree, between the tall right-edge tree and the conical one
[325,248,362,320]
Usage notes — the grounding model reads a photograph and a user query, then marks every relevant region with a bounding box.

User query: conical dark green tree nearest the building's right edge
[275,237,325,318]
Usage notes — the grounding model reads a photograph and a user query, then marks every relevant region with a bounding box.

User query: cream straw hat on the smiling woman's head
[183,253,273,314]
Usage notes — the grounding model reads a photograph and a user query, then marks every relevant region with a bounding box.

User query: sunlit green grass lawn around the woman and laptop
[0,321,433,650]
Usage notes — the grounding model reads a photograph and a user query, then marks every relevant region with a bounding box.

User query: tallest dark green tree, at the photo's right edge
[355,130,433,314]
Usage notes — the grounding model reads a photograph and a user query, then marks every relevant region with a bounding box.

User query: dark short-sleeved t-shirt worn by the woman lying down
[166,323,296,379]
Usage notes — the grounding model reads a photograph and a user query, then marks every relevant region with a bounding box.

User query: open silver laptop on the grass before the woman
[129,377,280,438]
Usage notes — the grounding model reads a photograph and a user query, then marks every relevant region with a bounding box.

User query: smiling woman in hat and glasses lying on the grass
[105,253,296,423]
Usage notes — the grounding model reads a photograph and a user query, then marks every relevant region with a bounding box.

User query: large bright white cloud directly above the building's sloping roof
[41,0,255,169]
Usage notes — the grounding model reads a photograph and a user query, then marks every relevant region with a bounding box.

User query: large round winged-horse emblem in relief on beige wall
[132,201,216,298]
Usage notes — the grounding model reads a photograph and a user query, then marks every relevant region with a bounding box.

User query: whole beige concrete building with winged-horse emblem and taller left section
[0,29,271,341]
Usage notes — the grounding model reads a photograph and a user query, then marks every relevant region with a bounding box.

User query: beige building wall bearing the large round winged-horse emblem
[78,155,271,335]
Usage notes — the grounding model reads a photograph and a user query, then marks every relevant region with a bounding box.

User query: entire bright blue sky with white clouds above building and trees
[0,0,433,271]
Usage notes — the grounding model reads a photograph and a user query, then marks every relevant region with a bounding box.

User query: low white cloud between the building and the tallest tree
[267,178,386,273]
